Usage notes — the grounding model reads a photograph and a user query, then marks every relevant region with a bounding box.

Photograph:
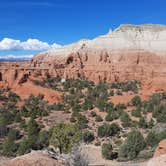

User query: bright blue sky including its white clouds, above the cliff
[0,0,166,57]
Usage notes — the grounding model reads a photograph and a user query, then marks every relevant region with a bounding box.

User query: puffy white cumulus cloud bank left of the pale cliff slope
[0,38,61,51]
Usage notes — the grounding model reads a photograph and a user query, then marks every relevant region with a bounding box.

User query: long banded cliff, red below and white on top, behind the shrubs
[0,24,166,91]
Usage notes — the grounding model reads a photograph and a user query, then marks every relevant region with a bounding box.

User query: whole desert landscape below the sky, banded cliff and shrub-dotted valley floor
[0,24,166,166]
